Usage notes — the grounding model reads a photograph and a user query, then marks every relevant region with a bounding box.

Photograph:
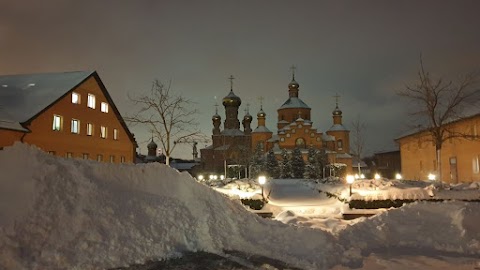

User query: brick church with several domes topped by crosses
[200,72,352,177]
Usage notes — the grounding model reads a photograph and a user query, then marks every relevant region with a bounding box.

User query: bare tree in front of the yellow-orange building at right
[397,56,480,181]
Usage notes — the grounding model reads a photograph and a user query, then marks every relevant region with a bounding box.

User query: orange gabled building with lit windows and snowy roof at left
[0,72,136,163]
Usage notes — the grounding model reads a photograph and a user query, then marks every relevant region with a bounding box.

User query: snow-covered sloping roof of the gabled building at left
[0,71,94,123]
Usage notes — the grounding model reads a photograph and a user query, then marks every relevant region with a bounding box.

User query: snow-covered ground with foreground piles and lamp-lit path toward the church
[0,144,480,269]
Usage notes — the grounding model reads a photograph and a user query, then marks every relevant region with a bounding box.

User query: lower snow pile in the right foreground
[339,202,480,256]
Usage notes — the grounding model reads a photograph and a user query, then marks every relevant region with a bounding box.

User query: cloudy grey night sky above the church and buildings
[0,0,480,158]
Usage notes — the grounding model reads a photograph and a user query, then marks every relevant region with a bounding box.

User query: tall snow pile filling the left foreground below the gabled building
[0,144,343,269]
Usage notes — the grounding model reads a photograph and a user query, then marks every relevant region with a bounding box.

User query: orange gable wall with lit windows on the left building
[24,77,135,163]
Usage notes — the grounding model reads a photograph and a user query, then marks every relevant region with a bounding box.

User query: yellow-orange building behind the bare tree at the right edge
[396,114,480,183]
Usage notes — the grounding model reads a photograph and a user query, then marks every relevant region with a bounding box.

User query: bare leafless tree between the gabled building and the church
[125,80,202,165]
